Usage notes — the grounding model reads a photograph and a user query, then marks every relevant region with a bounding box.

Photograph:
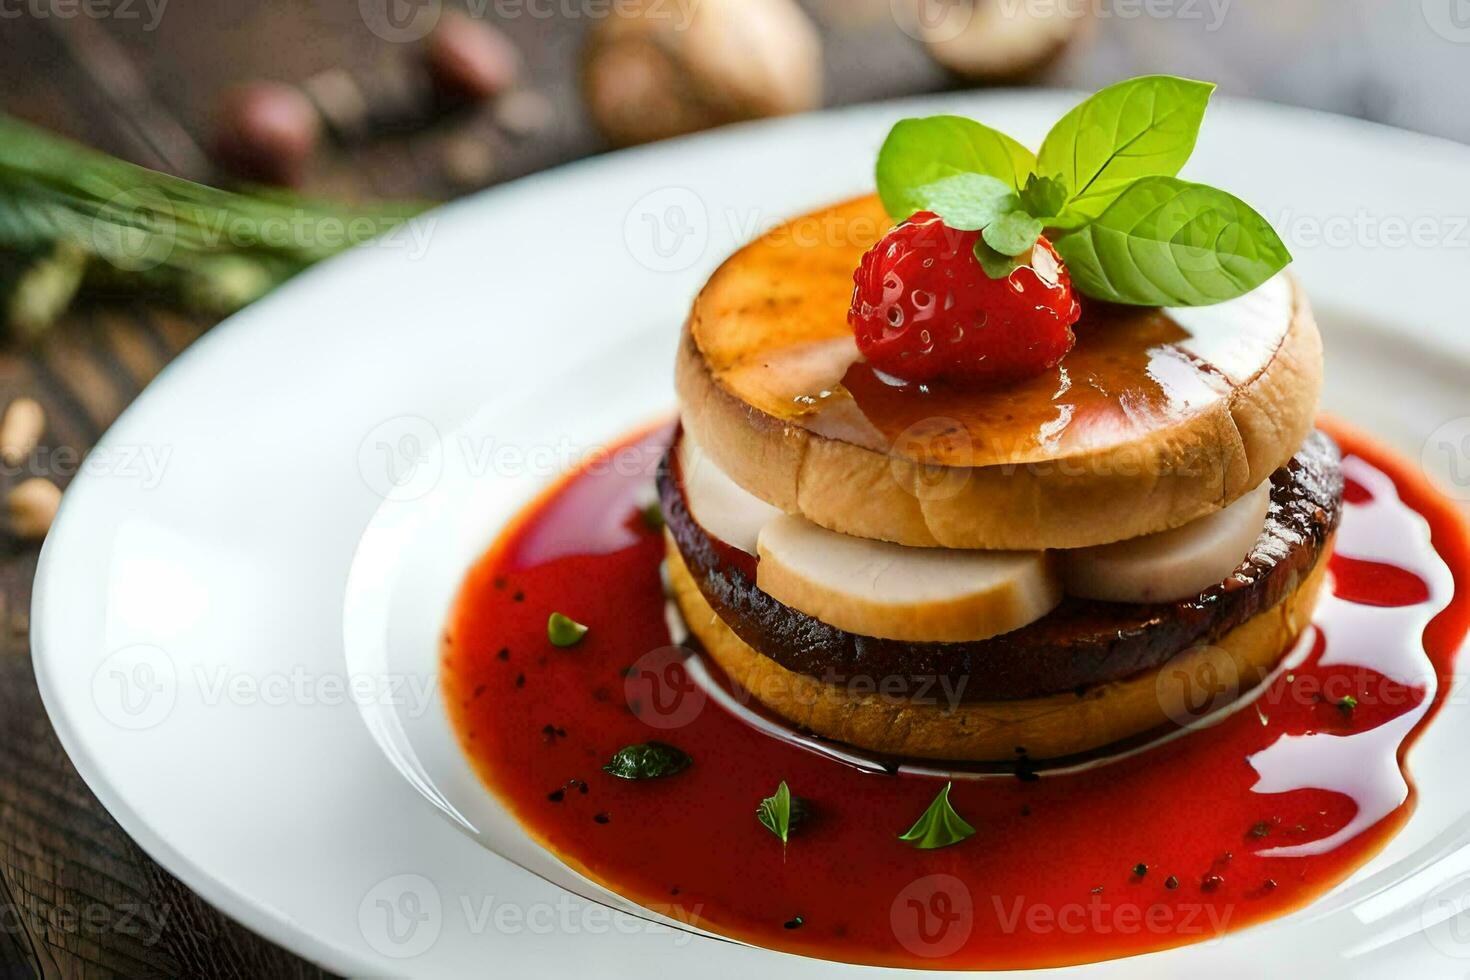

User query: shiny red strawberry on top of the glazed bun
[847,212,1082,385]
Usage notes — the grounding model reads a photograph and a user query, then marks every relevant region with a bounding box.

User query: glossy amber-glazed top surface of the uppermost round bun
[689,197,1314,466]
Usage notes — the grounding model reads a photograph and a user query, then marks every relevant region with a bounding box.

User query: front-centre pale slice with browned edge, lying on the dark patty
[756,516,1061,642]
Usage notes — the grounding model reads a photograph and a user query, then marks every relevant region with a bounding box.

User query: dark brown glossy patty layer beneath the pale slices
[659,430,1342,701]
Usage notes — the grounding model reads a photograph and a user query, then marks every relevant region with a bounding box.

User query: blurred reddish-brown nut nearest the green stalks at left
[215,82,322,185]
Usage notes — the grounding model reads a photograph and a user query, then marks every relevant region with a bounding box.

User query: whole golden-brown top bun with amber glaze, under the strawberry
[676,198,1322,550]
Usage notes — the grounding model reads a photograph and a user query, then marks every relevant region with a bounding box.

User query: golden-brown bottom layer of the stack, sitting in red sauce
[667,541,1330,761]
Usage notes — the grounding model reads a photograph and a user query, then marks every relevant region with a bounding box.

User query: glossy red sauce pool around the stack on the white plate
[444,423,1470,968]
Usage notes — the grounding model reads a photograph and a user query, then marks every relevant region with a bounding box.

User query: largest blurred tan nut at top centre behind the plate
[582,0,822,145]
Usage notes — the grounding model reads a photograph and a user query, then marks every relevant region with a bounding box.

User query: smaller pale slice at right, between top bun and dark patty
[1057,480,1272,602]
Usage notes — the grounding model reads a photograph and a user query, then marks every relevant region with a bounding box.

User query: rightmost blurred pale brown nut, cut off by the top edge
[911,0,1085,82]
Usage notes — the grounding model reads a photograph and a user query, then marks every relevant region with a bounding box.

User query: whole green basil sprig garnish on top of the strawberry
[878,75,1291,306]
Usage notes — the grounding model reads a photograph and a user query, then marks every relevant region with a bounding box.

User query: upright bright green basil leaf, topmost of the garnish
[1036,75,1214,228]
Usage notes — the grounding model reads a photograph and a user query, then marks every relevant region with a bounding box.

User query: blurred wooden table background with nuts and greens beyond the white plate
[0,0,1470,979]
